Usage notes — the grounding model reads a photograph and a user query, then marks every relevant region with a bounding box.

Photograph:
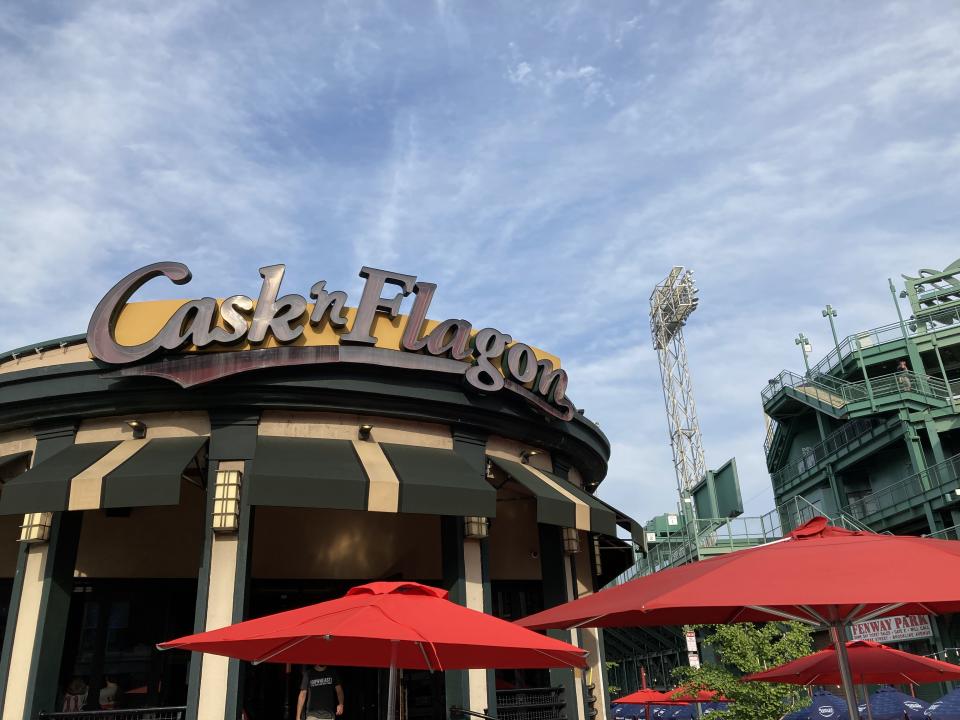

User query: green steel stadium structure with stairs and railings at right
[761,261,960,664]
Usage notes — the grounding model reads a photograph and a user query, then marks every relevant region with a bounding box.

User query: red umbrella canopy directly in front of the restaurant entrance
[160,582,586,670]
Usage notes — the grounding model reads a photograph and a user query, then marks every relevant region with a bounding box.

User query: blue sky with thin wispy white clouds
[0,0,960,521]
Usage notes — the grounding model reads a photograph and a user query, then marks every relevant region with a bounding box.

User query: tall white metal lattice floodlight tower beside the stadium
[650,266,707,497]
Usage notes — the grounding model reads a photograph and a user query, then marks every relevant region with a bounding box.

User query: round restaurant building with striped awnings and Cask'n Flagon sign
[0,263,643,720]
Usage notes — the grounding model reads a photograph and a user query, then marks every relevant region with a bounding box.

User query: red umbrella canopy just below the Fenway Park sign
[742,640,960,688]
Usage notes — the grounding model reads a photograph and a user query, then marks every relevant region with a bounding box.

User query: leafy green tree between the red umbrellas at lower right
[674,623,812,720]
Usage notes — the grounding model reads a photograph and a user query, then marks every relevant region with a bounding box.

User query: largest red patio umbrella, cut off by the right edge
[518,517,960,718]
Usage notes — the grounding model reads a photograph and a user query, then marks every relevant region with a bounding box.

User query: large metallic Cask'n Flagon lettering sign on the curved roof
[87,262,575,420]
